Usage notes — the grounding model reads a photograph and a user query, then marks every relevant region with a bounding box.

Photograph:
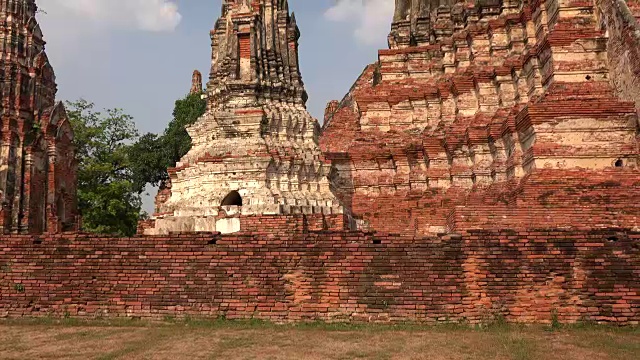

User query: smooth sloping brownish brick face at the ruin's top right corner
[596,0,640,115]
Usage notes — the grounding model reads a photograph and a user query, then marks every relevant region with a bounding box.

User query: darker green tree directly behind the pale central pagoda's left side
[130,93,207,193]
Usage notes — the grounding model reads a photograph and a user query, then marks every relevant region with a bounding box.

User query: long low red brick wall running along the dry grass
[0,229,640,324]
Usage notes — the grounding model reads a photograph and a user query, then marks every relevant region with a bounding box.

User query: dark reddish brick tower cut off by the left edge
[0,0,78,233]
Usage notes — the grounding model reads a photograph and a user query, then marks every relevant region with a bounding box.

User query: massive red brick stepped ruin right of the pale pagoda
[320,0,640,235]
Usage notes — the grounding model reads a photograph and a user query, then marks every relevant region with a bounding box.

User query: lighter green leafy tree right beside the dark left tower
[67,99,142,236]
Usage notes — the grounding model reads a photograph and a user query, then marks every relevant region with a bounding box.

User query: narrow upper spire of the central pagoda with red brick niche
[207,0,307,107]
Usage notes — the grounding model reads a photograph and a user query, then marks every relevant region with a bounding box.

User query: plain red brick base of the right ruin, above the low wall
[447,169,640,230]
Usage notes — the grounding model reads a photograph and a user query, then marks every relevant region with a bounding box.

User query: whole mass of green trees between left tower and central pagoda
[67,94,206,236]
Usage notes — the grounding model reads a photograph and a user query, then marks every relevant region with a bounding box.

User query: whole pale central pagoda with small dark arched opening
[143,0,345,234]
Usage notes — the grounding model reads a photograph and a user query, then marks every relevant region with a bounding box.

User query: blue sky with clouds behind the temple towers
[36,0,394,211]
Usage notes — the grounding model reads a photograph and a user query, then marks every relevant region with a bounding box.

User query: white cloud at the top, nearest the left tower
[38,0,182,31]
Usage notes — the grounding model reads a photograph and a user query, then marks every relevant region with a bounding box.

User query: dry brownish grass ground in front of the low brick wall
[0,321,640,360]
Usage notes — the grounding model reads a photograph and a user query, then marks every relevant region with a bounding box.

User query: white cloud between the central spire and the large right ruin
[325,0,395,44]
